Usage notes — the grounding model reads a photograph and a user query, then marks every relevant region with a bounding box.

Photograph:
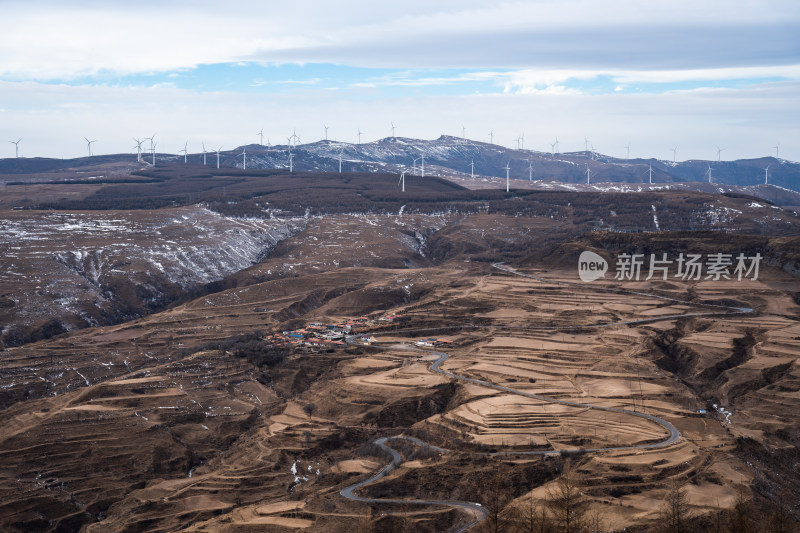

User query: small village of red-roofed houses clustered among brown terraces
[264,315,452,351]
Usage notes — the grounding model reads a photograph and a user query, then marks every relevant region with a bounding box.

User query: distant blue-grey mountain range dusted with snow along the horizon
[0,135,800,195]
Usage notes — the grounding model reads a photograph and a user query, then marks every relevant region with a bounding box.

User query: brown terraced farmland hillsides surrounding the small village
[0,206,800,533]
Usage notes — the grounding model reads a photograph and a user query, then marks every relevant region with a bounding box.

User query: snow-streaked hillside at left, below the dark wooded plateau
[0,206,305,340]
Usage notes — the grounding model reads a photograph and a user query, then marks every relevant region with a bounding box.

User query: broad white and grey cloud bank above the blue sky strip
[0,0,800,80]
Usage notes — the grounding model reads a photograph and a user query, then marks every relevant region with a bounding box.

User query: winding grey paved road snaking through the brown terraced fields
[339,263,753,533]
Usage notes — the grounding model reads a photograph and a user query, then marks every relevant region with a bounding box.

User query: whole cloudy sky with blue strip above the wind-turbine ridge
[0,0,800,161]
